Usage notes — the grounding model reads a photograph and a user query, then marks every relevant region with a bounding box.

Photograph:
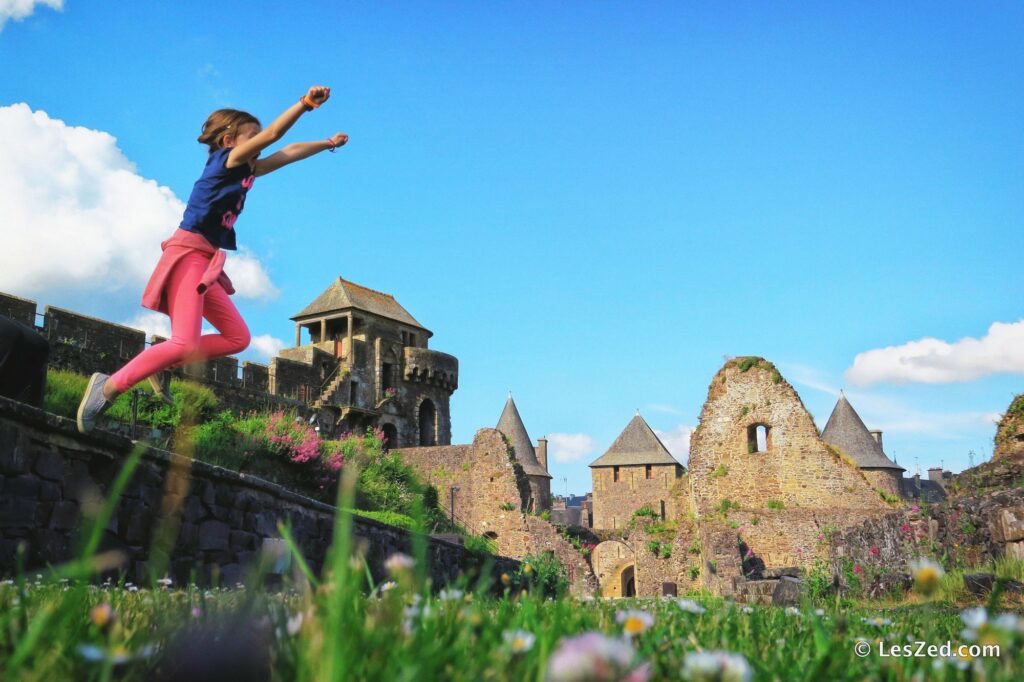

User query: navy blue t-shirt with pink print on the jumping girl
[179,148,256,251]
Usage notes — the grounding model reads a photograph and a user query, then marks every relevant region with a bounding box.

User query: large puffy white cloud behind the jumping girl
[0,102,278,307]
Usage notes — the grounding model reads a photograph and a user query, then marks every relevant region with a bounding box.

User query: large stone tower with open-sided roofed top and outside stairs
[282,278,459,447]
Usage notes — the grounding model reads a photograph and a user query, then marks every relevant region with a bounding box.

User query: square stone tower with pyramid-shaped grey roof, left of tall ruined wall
[590,412,686,529]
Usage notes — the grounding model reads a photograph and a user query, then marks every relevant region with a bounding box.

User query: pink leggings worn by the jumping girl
[111,252,250,392]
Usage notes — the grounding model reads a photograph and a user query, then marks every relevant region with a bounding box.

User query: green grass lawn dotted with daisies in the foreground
[0,570,1024,680]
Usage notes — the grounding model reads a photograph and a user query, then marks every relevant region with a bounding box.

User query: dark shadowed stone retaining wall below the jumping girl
[0,398,517,585]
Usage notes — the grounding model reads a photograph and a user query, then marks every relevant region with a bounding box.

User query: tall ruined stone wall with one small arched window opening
[689,358,890,587]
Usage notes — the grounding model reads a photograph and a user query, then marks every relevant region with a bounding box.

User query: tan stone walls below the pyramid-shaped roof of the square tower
[591,464,688,529]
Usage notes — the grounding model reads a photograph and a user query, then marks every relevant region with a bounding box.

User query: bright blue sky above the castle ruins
[0,0,1024,493]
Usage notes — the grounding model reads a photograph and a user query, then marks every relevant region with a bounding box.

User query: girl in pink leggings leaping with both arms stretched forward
[78,85,348,433]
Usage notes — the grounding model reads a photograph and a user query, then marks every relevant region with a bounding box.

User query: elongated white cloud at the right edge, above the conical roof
[846,319,1024,386]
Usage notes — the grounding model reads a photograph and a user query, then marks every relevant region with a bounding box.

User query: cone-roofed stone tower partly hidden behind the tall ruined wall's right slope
[821,391,906,497]
